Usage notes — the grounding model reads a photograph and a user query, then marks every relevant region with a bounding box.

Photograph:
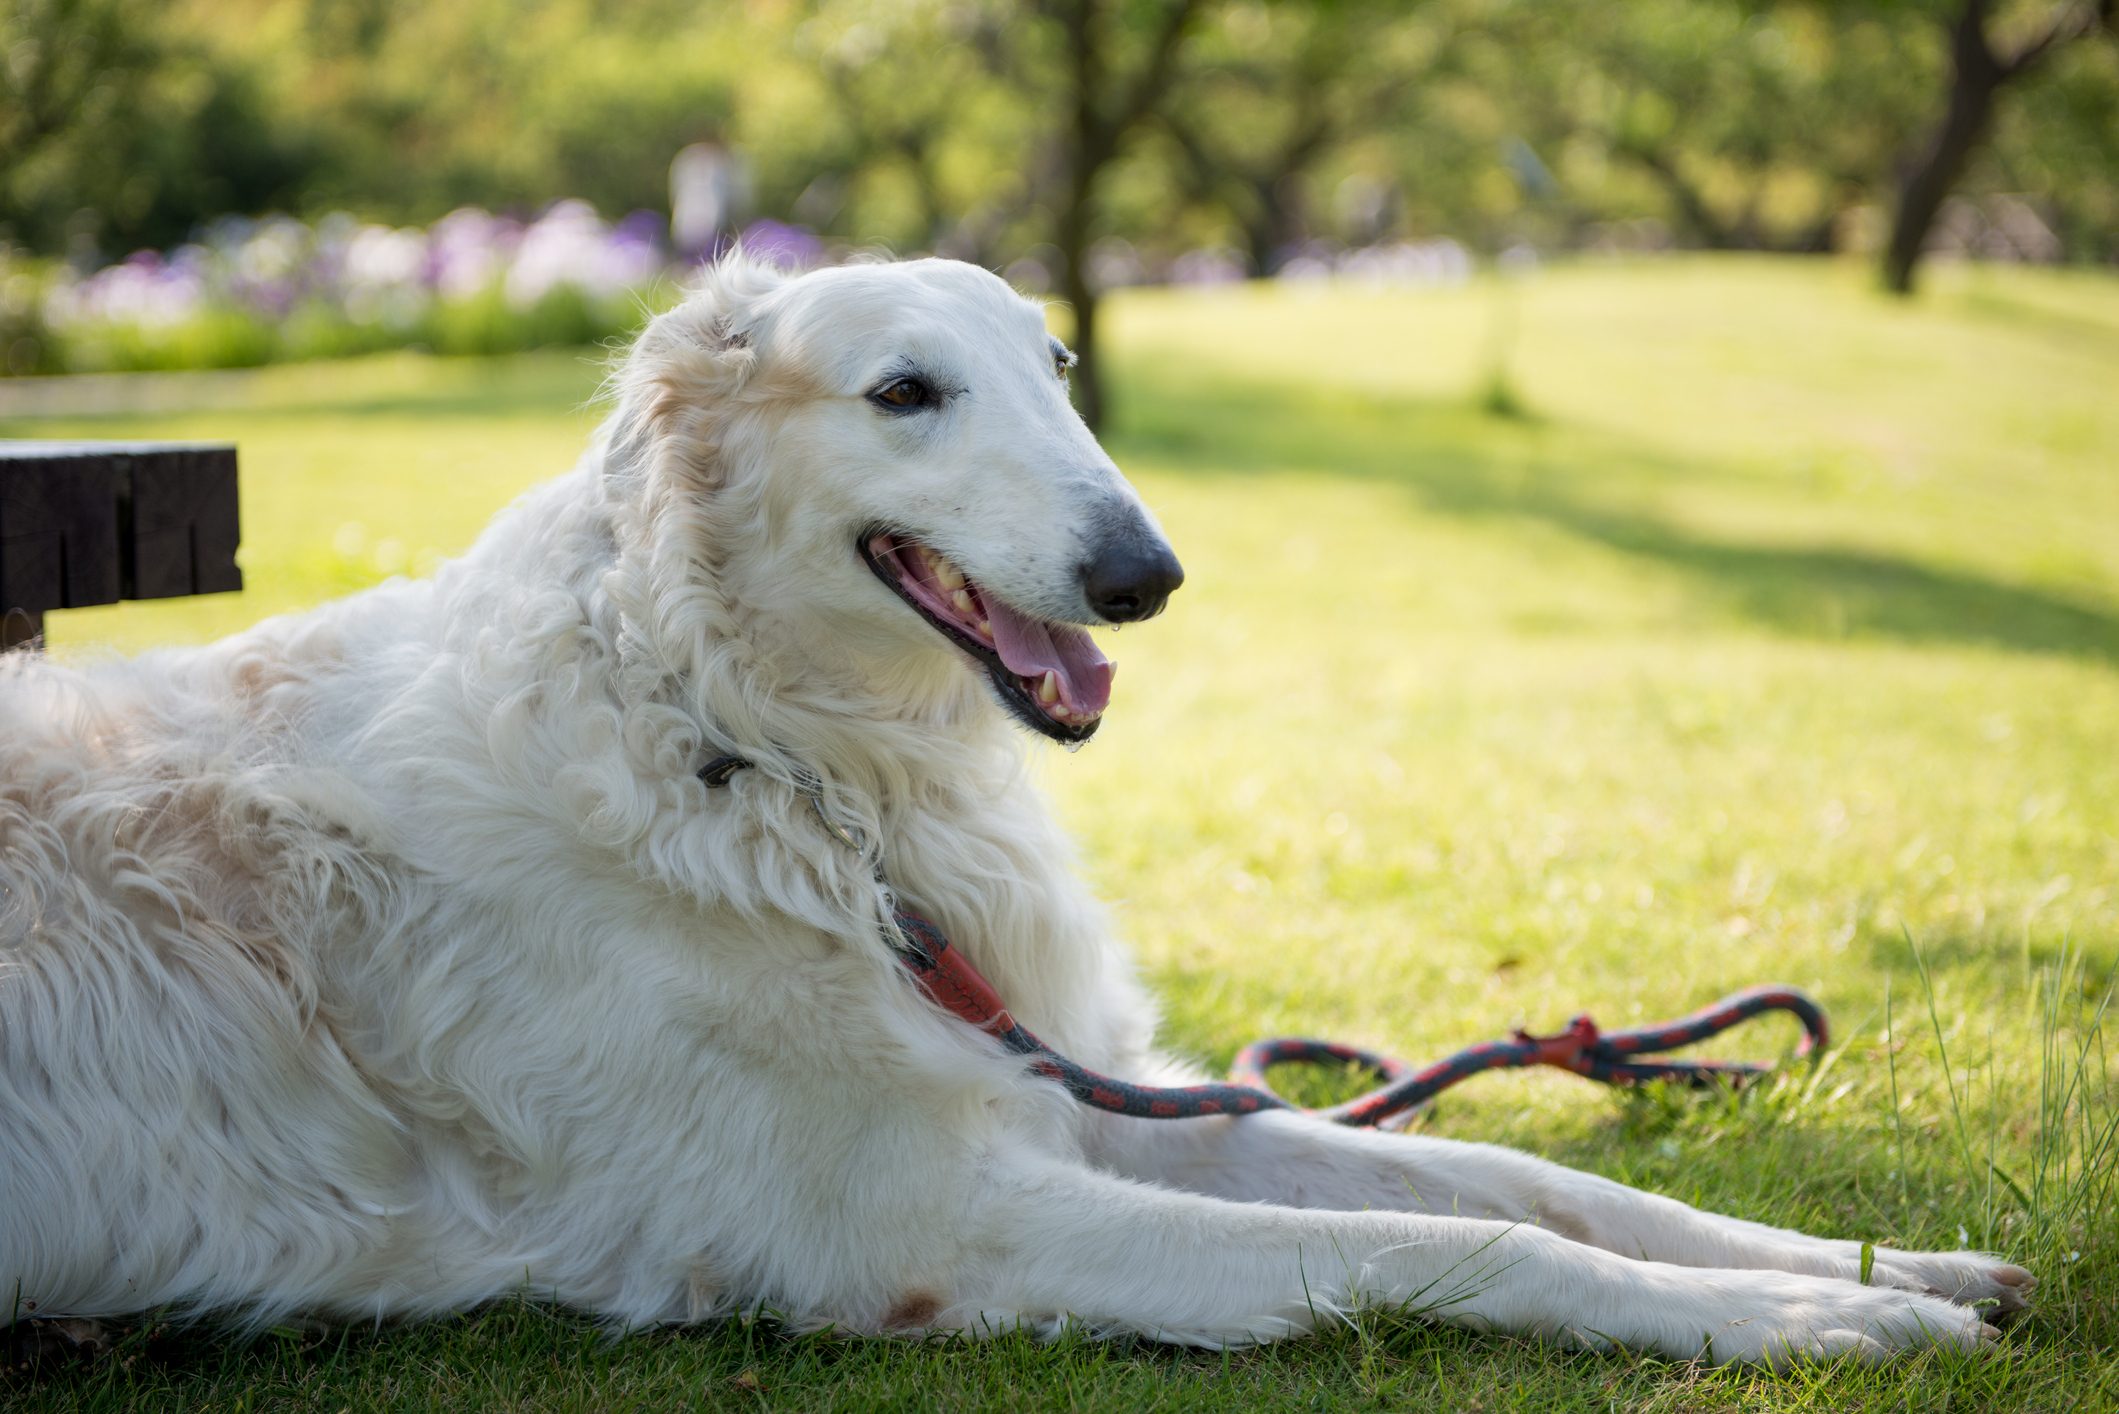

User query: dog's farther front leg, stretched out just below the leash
[1098,1113,2036,1312]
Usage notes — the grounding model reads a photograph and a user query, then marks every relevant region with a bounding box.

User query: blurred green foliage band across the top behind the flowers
[0,0,2119,288]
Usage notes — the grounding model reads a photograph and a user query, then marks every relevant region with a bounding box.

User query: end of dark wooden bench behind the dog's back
[0,441,244,651]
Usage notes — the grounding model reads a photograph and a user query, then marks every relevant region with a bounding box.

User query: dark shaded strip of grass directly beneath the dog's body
[0,1297,1542,1410]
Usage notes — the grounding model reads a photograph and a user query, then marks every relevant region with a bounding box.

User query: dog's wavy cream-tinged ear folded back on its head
[604,252,786,490]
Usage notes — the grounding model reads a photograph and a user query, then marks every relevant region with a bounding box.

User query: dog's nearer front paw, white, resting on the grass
[1666,1272,1998,1367]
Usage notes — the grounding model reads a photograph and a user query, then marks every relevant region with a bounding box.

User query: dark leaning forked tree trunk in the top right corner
[1884,0,2113,295]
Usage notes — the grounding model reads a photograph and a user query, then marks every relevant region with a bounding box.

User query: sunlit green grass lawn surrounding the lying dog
[0,259,2119,1410]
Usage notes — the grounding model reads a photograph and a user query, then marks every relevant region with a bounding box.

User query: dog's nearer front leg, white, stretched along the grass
[953,1162,1988,1361]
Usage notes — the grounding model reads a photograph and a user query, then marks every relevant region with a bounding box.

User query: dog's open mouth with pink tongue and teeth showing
[860,530,1117,742]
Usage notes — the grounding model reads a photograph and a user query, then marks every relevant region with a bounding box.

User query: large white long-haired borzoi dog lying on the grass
[0,261,2032,1361]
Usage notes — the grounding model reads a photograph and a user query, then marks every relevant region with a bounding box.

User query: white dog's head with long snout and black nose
[610,261,1185,742]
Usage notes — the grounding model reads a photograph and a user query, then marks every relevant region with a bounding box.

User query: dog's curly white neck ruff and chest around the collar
[434,436,1106,1058]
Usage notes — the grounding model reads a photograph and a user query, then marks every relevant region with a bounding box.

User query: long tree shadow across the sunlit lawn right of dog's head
[1110,369,2119,664]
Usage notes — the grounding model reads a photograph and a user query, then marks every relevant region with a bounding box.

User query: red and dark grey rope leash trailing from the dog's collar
[699,757,1831,1128]
